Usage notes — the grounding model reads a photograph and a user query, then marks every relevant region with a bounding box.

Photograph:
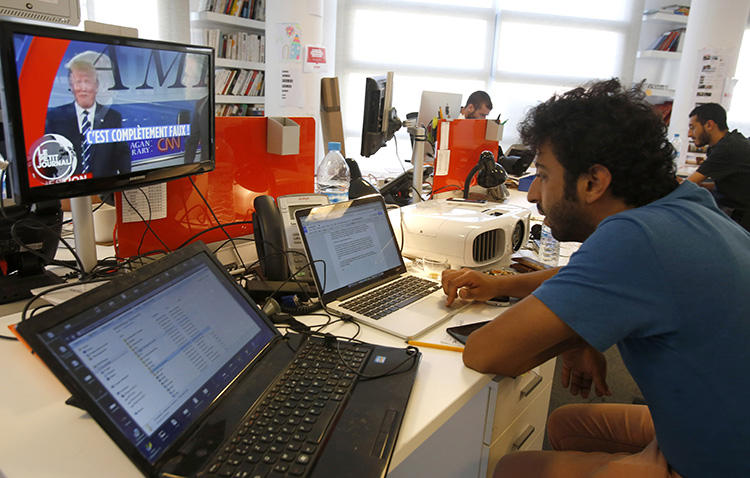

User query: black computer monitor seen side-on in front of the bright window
[360,72,401,158]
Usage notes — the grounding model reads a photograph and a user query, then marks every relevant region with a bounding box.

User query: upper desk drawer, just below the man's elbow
[484,359,555,444]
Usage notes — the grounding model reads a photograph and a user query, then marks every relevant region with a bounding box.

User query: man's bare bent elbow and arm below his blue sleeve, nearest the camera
[463,296,587,377]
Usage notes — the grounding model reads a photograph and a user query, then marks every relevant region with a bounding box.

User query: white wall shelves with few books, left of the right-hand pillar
[633,2,688,103]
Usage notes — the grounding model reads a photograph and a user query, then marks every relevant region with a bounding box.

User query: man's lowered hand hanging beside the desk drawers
[560,344,612,398]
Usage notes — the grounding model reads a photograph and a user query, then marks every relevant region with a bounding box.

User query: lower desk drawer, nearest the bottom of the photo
[483,384,551,478]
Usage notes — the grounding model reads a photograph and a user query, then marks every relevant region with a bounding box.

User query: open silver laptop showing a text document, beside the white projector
[295,195,465,339]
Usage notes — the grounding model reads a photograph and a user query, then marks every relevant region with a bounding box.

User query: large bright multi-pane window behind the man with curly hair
[336,0,641,172]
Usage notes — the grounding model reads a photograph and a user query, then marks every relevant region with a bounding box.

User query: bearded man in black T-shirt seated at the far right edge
[688,103,750,231]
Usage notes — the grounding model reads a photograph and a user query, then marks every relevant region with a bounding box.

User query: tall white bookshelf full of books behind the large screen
[190,4,266,116]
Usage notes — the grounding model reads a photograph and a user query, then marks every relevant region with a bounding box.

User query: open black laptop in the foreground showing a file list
[17,243,420,478]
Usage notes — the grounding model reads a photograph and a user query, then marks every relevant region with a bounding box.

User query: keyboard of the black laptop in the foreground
[201,341,370,478]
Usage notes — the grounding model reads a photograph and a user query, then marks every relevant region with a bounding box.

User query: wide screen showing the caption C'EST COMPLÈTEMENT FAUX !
[0,22,214,202]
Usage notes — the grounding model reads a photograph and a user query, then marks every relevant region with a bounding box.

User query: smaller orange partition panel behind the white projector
[432,119,497,192]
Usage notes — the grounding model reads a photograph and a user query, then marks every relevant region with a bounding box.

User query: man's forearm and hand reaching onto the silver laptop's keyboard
[442,267,560,305]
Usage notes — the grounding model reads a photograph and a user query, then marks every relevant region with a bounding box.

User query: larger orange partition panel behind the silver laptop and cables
[115,117,315,257]
